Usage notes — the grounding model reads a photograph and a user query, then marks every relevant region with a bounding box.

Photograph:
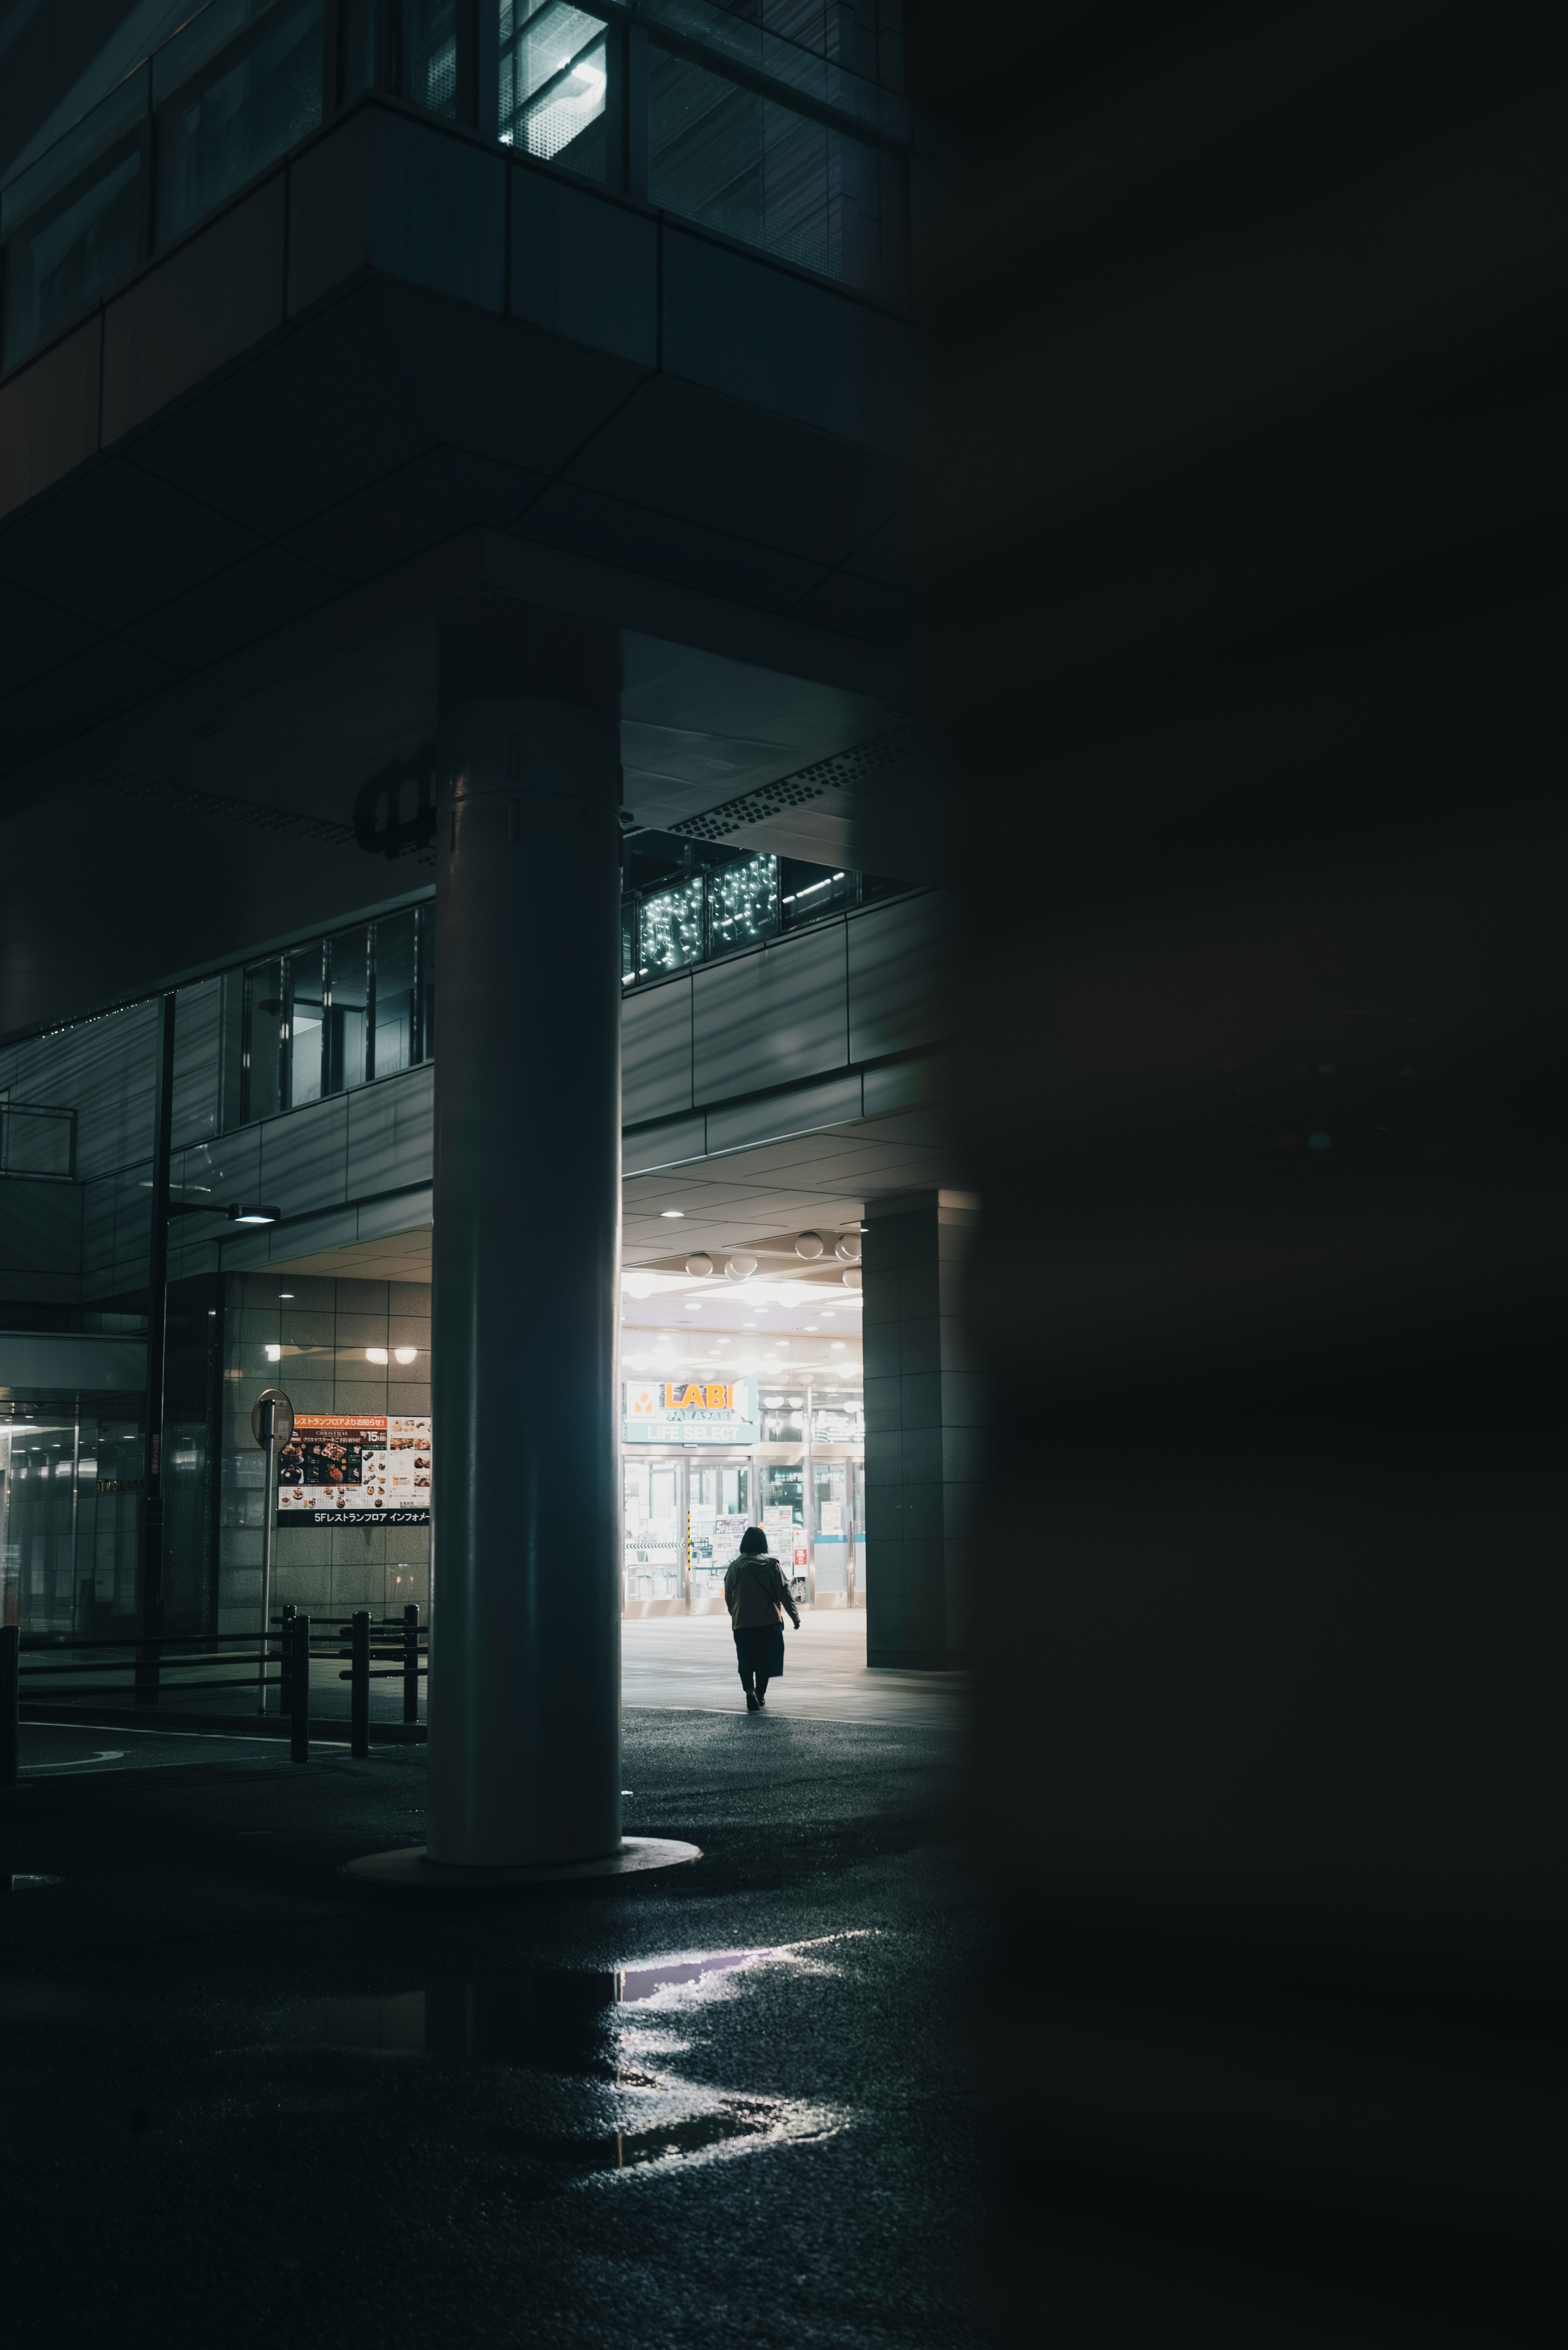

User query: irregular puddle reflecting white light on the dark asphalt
[294,1936,844,2192]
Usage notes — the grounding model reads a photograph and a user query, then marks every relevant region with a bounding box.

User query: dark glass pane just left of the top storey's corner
[153,0,322,240]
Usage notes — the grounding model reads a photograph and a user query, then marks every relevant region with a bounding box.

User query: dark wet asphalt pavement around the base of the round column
[0,1708,978,2350]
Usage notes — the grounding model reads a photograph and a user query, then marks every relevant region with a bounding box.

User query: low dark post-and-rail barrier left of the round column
[0,1607,430,1786]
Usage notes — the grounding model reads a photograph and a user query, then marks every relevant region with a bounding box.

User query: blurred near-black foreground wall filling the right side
[919,5,1568,2350]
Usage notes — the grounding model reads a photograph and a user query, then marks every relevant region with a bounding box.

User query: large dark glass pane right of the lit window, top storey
[649,47,882,292]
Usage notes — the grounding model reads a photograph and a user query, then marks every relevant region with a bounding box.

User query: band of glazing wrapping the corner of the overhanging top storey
[0,0,910,367]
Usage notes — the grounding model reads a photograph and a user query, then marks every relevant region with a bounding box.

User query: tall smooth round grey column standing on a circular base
[428,599,621,1868]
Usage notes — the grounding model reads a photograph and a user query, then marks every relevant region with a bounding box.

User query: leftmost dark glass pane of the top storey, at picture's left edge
[0,68,148,367]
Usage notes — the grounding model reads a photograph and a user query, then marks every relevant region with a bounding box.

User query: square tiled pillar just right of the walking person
[863,1192,982,1671]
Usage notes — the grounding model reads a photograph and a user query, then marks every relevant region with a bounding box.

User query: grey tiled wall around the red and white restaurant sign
[218,1274,440,1631]
